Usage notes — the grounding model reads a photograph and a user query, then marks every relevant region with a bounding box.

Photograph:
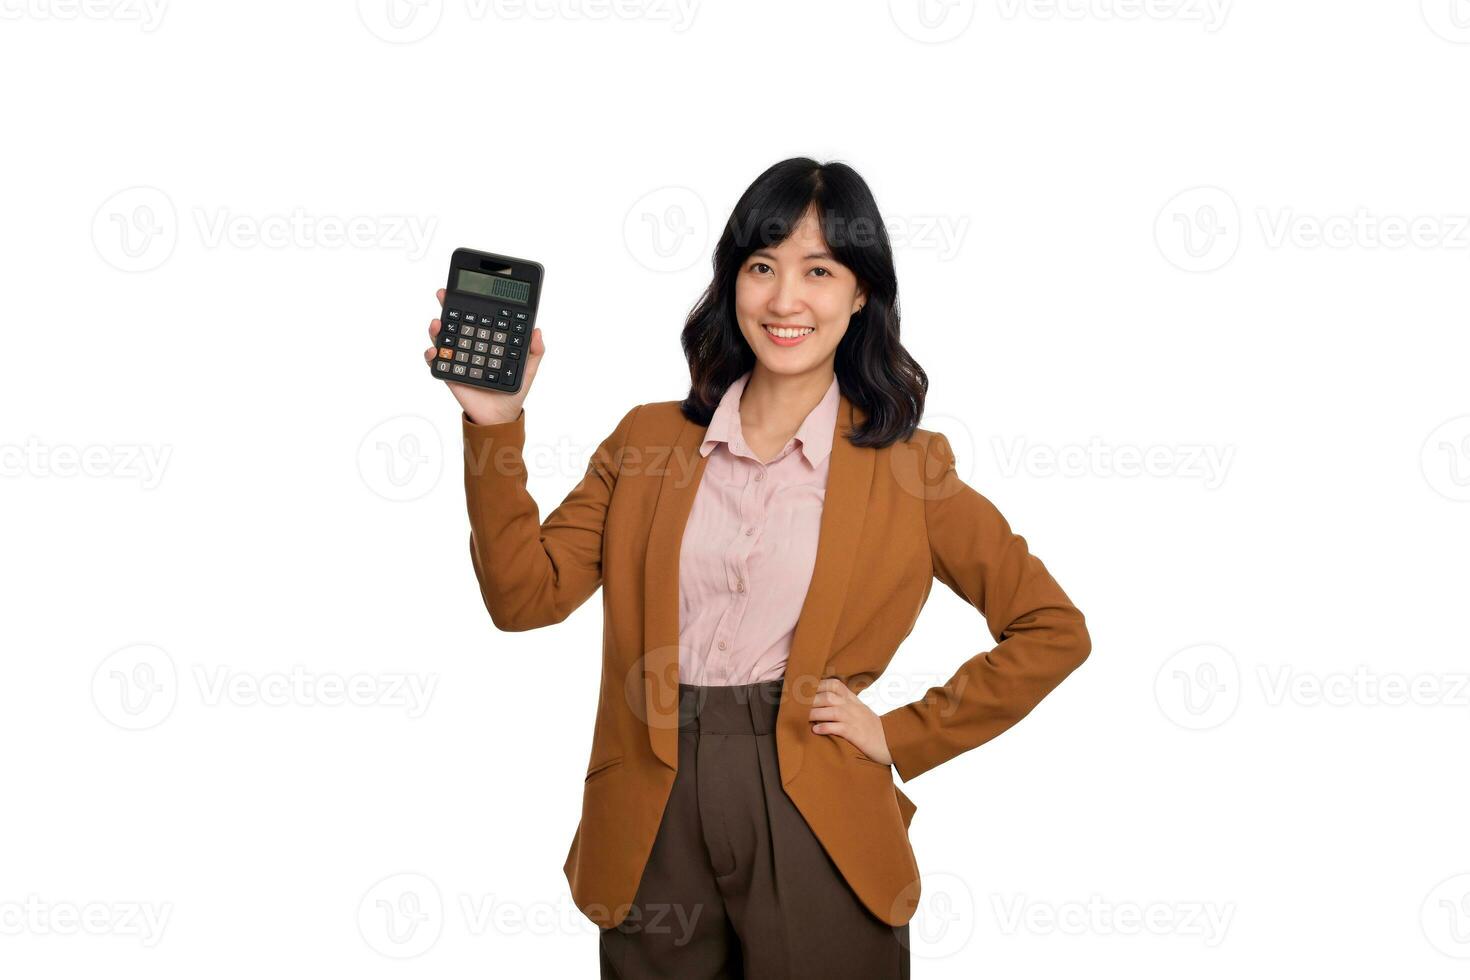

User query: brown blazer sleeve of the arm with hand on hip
[881,433,1092,780]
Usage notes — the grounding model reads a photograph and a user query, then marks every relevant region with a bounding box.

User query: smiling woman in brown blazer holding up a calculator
[425,157,1091,980]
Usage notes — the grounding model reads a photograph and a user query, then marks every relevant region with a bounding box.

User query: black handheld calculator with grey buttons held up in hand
[431,248,545,392]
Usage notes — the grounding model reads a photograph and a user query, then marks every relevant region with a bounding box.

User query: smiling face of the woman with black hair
[735,206,867,375]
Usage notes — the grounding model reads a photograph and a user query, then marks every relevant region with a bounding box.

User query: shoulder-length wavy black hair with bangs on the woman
[679,157,929,447]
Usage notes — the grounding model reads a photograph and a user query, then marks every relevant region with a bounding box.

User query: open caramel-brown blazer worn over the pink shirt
[460,394,1091,929]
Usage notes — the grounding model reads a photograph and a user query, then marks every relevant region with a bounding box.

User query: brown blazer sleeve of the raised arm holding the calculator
[460,406,641,632]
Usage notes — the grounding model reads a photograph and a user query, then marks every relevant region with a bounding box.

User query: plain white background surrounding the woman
[0,0,1470,979]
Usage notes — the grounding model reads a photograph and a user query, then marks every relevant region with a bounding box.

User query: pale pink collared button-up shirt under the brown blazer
[679,372,838,685]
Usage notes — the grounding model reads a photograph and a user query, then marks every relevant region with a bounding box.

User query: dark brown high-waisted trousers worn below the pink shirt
[598,680,908,980]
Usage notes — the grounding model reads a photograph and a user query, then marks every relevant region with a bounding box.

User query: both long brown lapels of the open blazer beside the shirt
[642,392,875,783]
